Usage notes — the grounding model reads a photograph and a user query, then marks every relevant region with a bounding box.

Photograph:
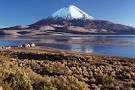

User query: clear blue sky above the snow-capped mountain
[0,0,135,27]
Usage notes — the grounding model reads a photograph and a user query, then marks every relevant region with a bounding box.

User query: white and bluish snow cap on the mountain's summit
[52,5,94,20]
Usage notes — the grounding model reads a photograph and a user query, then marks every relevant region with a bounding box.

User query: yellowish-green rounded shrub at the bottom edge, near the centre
[52,76,88,90]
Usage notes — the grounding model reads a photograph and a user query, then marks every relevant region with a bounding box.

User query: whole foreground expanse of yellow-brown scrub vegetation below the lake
[0,48,135,90]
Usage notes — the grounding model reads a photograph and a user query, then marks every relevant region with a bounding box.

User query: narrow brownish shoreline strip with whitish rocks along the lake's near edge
[0,43,135,59]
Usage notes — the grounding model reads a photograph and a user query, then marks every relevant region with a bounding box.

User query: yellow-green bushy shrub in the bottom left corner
[4,71,32,90]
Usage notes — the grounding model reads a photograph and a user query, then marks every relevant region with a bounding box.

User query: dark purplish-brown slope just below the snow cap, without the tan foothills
[30,18,135,34]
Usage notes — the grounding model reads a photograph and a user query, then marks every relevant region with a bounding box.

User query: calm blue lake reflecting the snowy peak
[0,35,135,58]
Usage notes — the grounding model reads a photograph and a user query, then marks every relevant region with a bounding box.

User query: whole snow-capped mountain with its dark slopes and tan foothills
[0,5,135,35]
